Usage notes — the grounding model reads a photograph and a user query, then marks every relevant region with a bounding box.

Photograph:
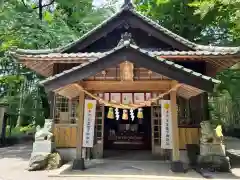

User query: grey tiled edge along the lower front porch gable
[40,41,220,84]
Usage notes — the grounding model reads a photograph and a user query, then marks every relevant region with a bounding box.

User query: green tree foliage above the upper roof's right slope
[135,0,240,46]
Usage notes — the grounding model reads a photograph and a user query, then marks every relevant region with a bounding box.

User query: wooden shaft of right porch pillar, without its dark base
[170,81,180,162]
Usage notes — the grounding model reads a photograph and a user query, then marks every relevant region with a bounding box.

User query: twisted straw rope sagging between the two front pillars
[72,84,183,110]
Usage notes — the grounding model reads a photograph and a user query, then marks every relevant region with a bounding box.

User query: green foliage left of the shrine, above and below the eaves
[0,0,112,128]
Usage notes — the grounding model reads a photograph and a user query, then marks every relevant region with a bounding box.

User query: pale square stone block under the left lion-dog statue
[31,140,55,156]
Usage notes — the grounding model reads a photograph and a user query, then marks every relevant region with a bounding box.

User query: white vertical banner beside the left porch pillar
[83,99,97,147]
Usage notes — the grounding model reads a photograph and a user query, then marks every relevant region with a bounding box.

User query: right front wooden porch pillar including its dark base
[170,81,184,172]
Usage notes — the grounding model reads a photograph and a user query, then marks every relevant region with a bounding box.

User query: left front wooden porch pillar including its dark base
[72,91,85,170]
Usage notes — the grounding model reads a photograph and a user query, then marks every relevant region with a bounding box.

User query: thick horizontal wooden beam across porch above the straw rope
[80,80,171,92]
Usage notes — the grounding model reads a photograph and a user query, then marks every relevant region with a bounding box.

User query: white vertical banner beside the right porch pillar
[161,100,173,149]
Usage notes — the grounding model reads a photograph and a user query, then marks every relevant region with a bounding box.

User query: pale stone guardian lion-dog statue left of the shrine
[35,119,53,141]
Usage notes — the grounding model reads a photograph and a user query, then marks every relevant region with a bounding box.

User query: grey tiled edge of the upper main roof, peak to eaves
[8,6,240,54]
